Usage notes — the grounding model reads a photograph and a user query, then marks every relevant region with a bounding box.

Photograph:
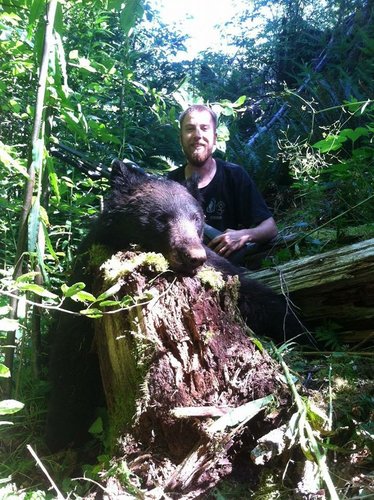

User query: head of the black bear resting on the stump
[99,160,206,274]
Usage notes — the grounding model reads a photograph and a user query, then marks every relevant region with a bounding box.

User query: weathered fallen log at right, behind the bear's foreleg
[250,239,374,343]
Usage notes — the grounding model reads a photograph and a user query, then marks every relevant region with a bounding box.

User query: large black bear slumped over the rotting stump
[46,160,298,452]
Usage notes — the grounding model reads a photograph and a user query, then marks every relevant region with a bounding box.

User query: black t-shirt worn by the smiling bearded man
[168,159,272,231]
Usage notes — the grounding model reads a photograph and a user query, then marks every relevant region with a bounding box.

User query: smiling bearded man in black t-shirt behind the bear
[169,104,277,263]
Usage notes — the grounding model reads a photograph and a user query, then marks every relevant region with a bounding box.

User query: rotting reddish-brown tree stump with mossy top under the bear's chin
[96,253,288,498]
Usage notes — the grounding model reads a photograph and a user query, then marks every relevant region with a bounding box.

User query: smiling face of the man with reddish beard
[181,111,217,167]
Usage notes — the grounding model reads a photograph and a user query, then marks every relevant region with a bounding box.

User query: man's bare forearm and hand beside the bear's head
[208,217,278,257]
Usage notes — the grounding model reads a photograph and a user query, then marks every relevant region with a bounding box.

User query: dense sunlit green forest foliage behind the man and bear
[0,0,374,494]
